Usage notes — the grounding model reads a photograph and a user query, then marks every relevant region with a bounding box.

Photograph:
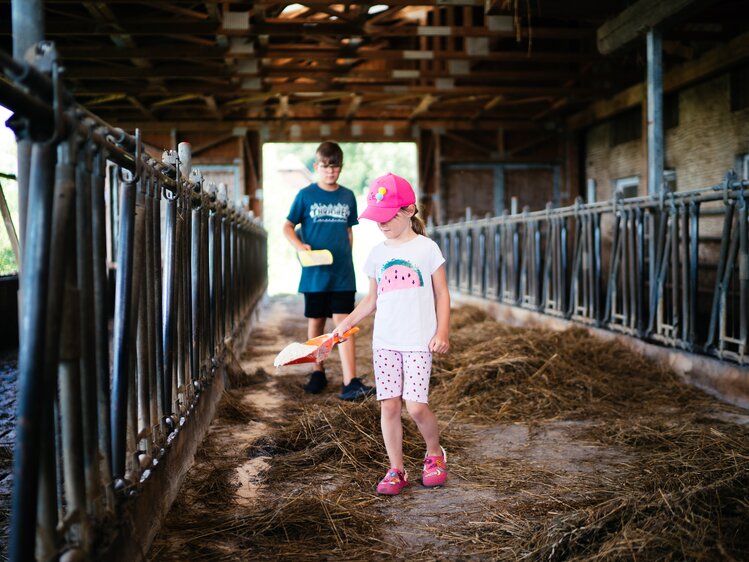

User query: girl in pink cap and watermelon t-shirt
[334,174,450,495]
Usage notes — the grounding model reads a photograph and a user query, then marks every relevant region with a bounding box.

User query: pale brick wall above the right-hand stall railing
[585,74,749,200]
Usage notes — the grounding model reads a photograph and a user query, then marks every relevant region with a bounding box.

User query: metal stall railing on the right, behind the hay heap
[430,172,749,365]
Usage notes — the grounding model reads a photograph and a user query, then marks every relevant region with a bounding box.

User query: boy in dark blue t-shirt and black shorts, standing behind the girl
[283,142,374,400]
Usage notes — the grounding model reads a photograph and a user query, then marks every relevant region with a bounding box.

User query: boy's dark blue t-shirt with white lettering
[286,183,359,293]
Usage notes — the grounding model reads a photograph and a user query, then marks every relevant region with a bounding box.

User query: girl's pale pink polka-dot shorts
[372,349,432,404]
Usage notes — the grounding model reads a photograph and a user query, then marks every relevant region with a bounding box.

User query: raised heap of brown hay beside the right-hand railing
[430,307,714,422]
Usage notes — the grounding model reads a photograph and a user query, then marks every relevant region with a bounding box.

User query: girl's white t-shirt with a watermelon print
[364,235,445,351]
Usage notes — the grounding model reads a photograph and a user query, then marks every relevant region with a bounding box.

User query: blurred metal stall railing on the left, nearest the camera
[0,43,267,561]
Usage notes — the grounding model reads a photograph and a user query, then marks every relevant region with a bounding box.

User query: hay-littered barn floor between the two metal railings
[148,296,749,561]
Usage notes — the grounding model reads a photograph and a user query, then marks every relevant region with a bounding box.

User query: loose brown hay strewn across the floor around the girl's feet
[150,307,749,560]
